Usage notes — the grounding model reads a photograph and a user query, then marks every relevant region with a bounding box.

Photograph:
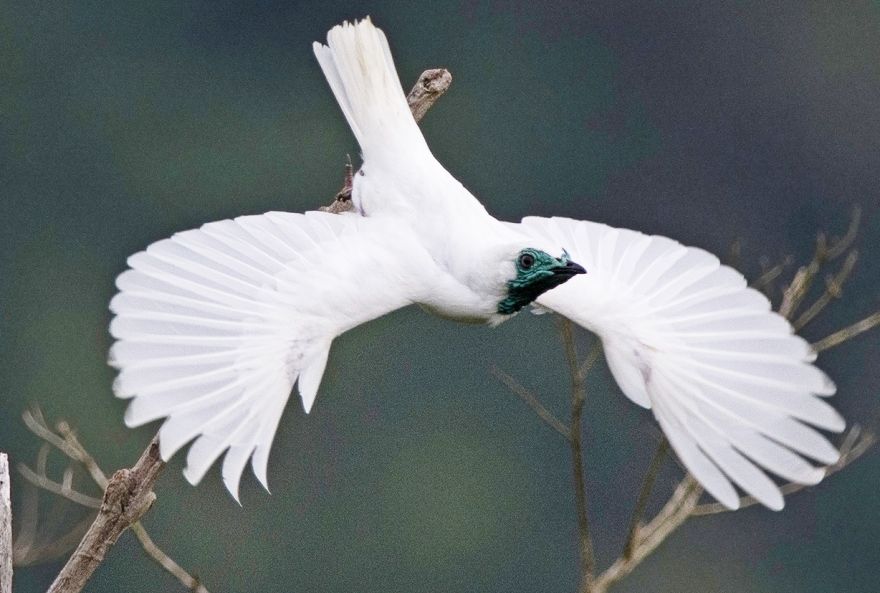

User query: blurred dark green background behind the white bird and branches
[0,0,880,593]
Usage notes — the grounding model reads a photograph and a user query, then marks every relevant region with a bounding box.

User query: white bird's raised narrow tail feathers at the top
[313,17,428,161]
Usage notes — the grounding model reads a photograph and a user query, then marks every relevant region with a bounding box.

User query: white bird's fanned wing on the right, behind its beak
[518,218,844,509]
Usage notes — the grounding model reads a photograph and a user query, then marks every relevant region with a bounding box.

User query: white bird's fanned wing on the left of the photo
[110,212,430,497]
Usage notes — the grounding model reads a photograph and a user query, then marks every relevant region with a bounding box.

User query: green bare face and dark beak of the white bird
[498,247,587,315]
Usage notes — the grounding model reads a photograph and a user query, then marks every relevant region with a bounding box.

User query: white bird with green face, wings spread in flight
[110,19,844,509]
